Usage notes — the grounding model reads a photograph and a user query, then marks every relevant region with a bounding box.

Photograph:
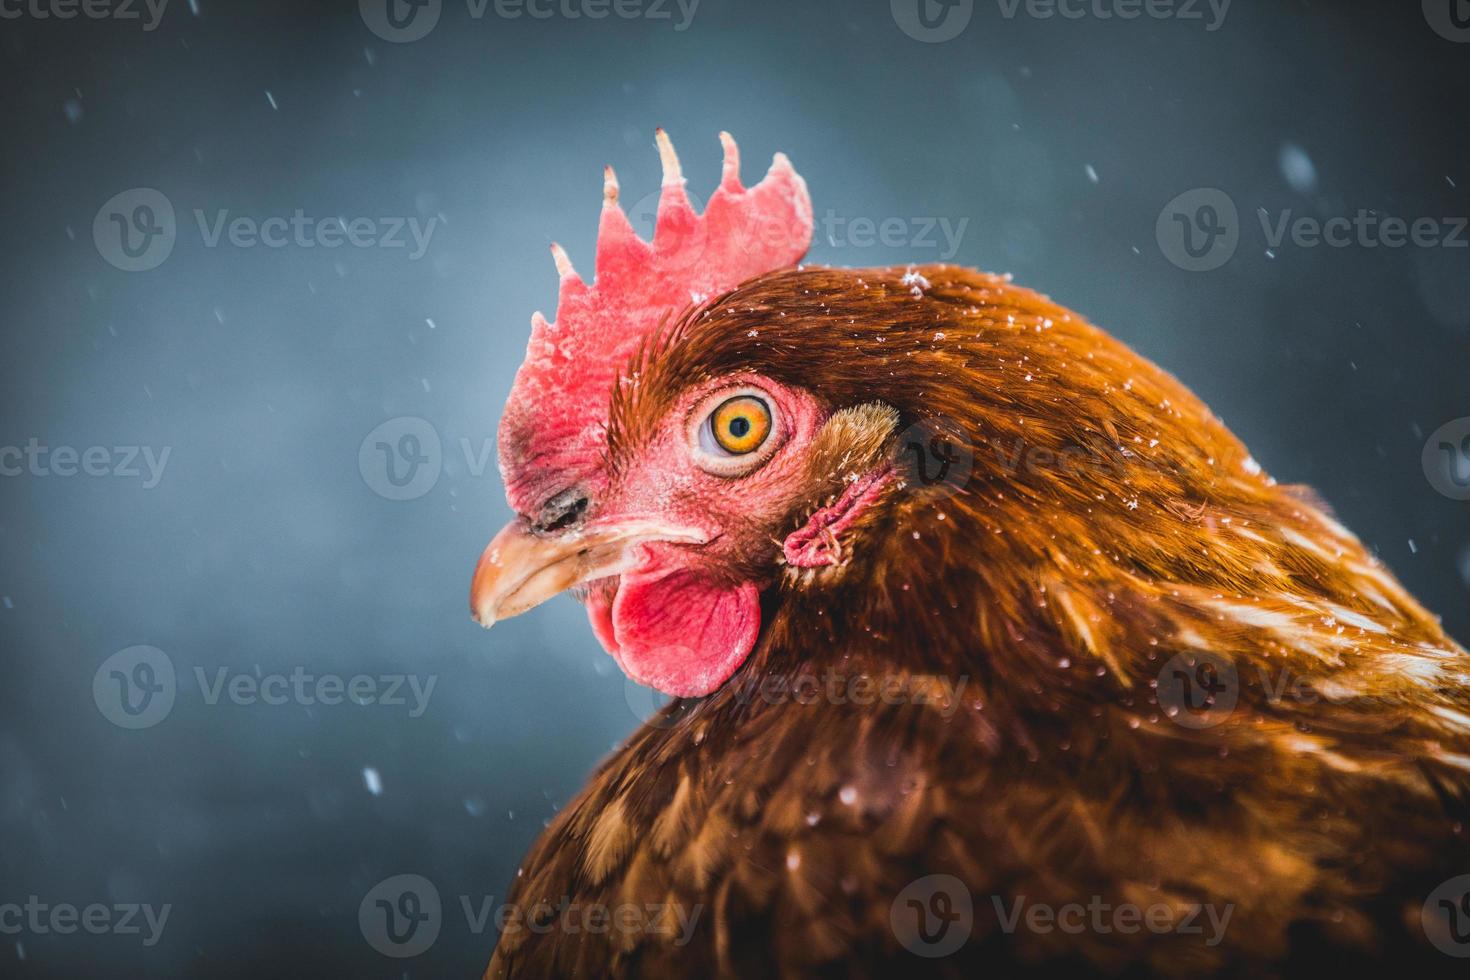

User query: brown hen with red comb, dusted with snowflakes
[470,132,1470,977]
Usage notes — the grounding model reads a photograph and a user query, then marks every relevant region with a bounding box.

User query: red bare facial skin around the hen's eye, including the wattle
[585,375,826,696]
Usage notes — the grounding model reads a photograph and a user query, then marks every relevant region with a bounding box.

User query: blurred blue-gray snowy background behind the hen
[0,0,1470,977]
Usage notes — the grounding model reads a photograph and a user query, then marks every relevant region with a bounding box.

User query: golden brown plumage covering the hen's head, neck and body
[487,266,1470,977]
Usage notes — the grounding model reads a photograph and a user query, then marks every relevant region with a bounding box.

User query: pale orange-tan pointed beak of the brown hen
[469,519,709,629]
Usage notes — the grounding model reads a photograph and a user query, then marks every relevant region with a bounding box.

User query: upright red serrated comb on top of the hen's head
[500,129,811,516]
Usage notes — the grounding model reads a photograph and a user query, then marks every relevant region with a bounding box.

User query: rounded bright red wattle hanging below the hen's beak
[600,569,760,698]
